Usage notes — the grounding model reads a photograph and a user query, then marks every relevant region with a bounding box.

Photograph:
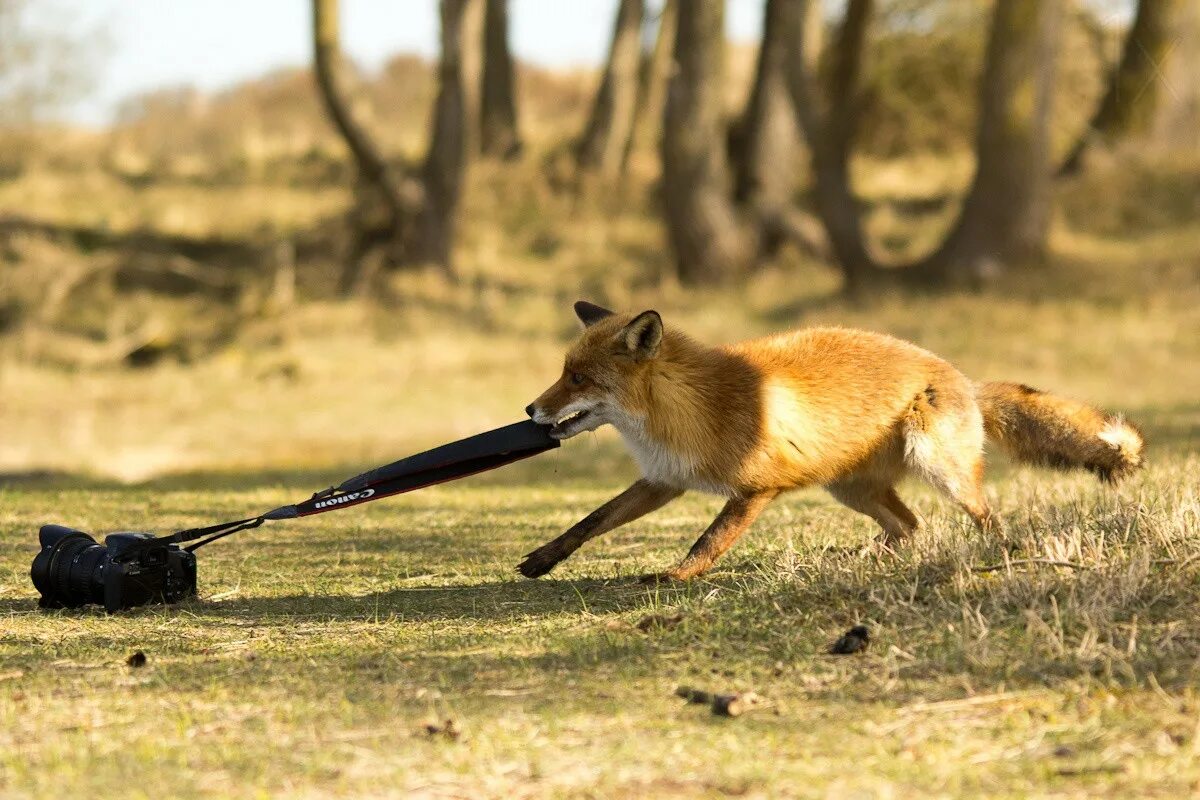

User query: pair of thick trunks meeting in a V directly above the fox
[661,0,826,283]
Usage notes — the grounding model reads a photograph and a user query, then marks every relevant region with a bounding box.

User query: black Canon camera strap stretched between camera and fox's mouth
[137,420,562,552]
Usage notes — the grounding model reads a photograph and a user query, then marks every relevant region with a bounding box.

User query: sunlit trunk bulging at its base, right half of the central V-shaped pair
[733,0,818,215]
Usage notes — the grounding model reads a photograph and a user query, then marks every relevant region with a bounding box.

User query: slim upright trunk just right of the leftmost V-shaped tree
[479,0,521,160]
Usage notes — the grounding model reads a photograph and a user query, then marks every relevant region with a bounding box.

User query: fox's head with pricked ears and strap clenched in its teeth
[526,300,662,439]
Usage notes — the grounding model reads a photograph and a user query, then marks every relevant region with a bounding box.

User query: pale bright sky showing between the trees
[52,0,762,124]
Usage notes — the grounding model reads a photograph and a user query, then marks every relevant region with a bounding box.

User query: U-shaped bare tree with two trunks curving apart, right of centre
[791,0,1063,291]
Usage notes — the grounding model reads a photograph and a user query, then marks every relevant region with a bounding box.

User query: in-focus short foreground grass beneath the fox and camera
[0,444,1200,796]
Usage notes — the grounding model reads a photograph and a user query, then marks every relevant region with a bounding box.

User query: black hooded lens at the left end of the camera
[30,525,108,608]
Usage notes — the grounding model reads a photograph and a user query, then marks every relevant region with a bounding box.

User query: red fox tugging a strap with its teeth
[517,301,1145,581]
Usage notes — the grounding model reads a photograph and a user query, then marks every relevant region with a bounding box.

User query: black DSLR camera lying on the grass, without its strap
[30,525,196,614]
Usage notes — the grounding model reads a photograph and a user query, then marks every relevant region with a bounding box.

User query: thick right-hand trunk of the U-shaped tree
[923,0,1063,283]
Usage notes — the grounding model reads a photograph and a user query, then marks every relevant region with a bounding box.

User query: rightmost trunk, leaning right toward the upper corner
[1060,0,1195,174]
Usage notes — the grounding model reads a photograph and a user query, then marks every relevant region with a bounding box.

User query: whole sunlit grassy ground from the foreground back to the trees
[0,149,1200,798]
